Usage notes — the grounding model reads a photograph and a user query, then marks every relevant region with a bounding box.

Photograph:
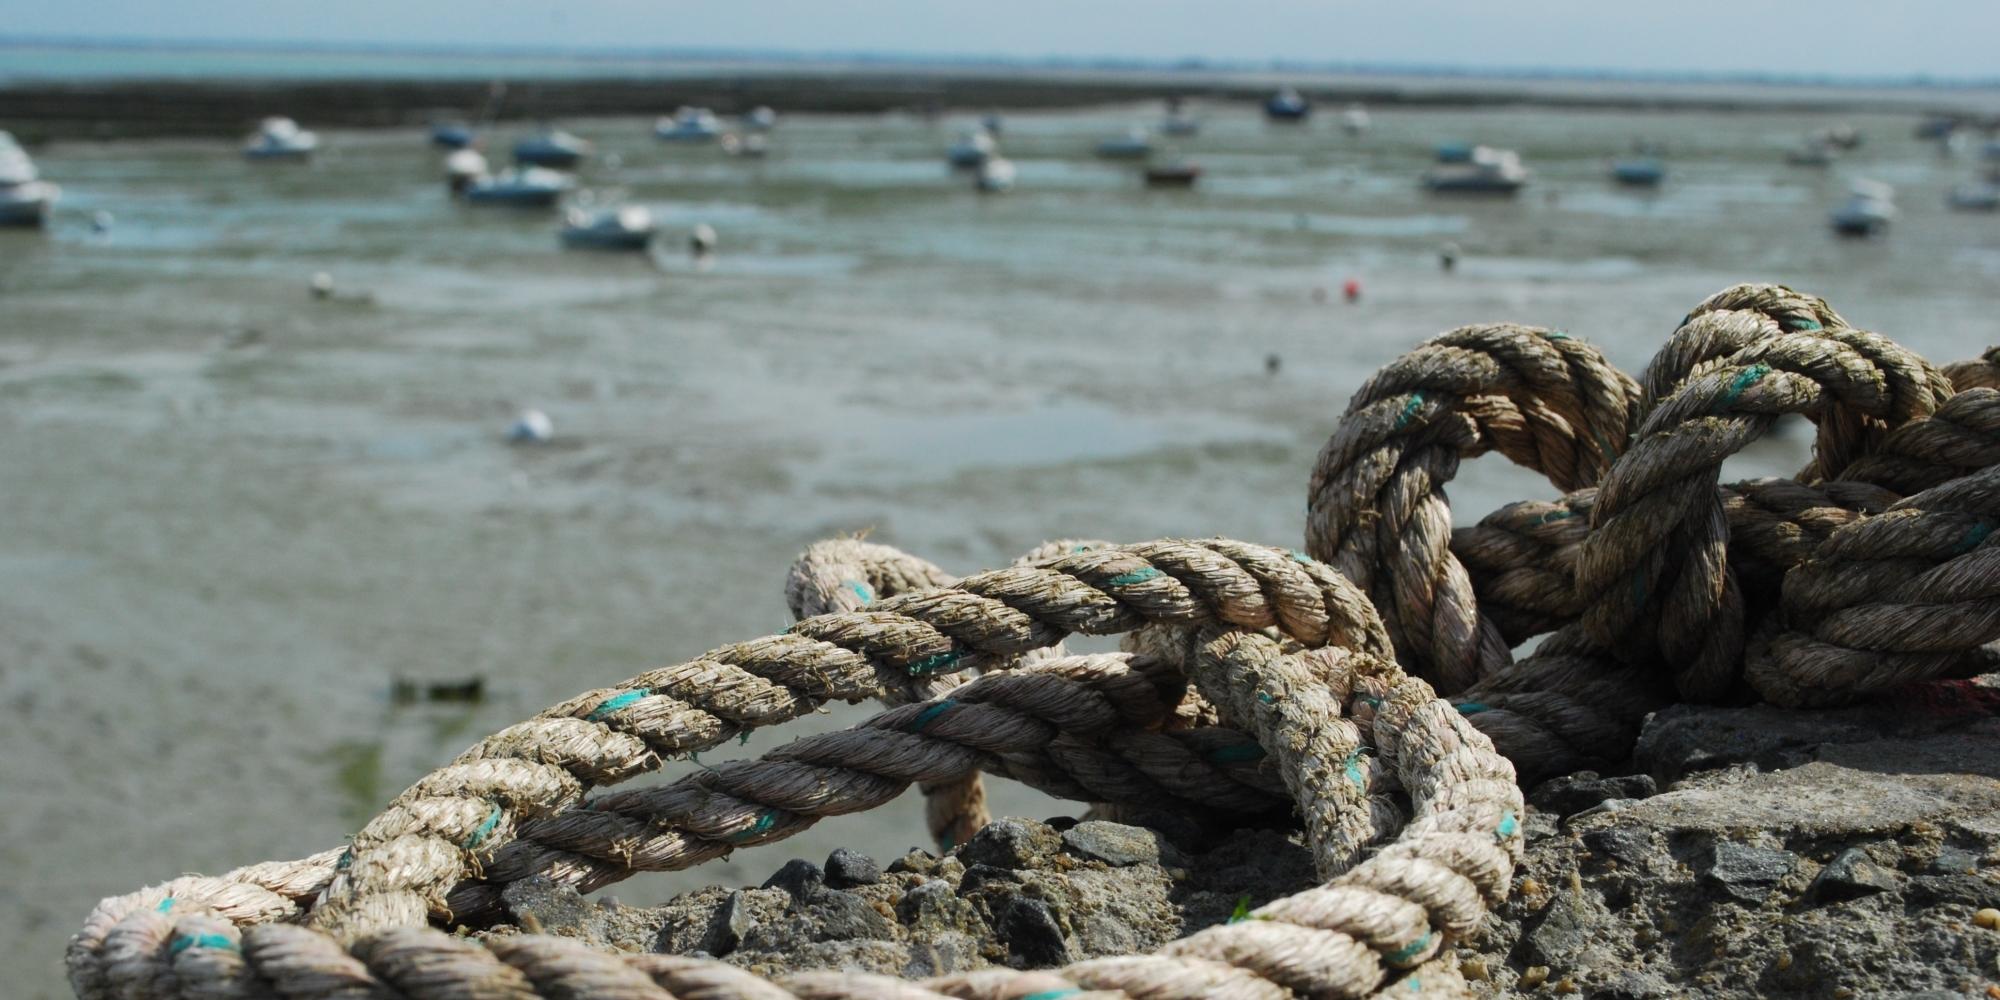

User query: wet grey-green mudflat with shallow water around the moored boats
[0,99,2000,996]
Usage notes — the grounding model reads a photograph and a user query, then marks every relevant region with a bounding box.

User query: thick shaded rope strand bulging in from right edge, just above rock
[1746,466,2000,706]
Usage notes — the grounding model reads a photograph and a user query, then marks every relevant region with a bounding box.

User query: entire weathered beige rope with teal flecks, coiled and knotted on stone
[68,286,2000,1000]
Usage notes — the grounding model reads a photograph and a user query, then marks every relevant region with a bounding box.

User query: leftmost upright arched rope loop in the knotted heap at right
[1306,324,1638,690]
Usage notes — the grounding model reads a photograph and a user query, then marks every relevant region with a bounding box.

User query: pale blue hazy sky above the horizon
[0,0,2000,78]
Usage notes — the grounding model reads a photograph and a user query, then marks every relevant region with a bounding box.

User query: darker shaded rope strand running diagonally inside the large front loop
[448,654,1290,922]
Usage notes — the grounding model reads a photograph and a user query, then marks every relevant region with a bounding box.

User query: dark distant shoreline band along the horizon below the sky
[0,60,2000,142]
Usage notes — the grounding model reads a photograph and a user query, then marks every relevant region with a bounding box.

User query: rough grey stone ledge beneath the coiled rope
[502,702,2000,1000]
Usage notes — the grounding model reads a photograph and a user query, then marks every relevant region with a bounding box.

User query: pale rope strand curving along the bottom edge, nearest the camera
[70,620,1522,1000]
